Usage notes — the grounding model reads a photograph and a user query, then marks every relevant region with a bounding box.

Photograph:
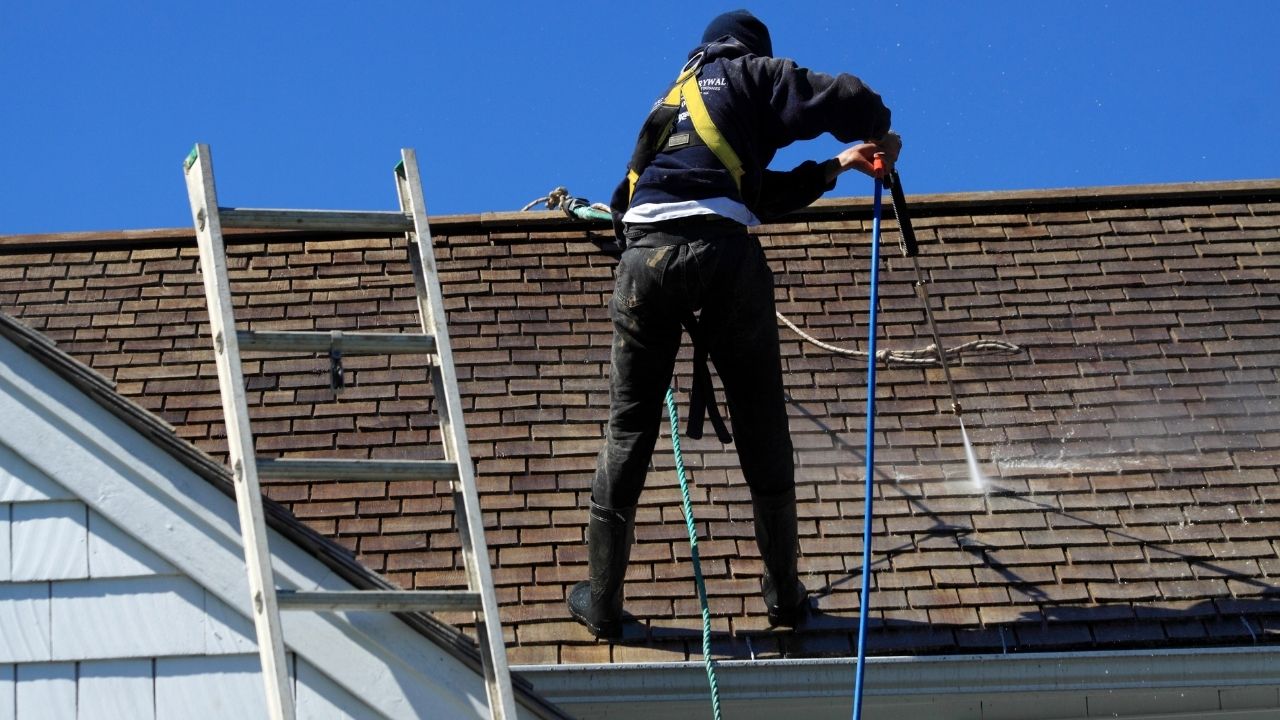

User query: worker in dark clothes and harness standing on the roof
[568,4,901,638]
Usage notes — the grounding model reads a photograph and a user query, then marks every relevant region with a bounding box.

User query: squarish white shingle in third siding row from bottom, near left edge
[10,501,88,582]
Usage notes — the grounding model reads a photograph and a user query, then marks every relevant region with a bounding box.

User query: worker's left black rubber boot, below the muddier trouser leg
[568,501,636,638]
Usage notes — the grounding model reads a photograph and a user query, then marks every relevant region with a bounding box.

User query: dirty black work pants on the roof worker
[591,223,795,509]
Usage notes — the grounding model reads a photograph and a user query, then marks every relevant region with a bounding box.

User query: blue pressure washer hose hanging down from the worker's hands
[854,155,884,720]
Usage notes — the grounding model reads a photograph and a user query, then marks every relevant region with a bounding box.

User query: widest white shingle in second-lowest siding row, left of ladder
[52,575,205,660]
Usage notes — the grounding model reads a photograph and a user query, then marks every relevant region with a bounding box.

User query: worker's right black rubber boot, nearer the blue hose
[751,491,809,628]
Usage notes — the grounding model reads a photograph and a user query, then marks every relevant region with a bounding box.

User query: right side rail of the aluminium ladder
[396,149,516,720]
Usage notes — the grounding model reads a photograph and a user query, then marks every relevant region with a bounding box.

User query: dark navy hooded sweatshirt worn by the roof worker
[611,37,890,220]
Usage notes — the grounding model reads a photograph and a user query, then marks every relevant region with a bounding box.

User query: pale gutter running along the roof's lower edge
[512,646,1280,717]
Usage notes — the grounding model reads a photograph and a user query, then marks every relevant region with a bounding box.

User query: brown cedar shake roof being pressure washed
[0,181,1280,664]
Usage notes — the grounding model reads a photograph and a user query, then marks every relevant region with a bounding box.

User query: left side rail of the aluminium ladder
[186,143,294,720]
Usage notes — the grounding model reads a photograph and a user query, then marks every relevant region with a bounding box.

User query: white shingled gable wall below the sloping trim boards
[0,441,379,720]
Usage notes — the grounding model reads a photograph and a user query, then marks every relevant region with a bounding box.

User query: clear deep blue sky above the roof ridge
[0,0,1280,234]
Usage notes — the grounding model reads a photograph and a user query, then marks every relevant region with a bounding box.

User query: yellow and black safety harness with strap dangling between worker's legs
[613,53,744,445]
